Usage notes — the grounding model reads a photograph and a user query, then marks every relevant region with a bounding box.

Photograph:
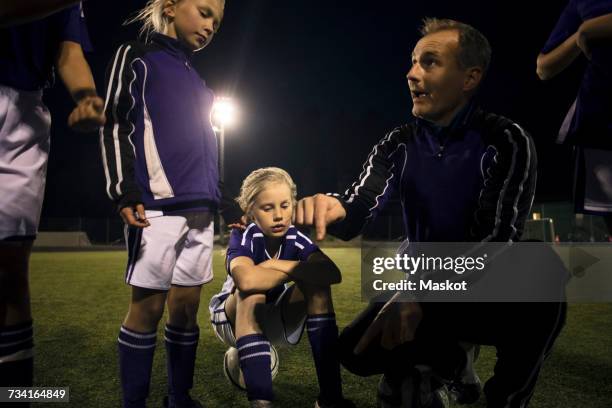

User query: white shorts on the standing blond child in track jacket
[125,211,214,290]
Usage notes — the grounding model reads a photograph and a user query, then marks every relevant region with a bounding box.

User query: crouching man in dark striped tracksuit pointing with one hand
[296,19,565,408]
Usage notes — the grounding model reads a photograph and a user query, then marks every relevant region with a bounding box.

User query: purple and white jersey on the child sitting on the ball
[209,223,319,313]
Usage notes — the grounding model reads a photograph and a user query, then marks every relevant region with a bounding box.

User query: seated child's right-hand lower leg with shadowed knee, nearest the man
[294,283,343,405]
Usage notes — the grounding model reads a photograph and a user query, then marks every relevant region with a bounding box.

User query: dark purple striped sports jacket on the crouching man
[330,106,537,242]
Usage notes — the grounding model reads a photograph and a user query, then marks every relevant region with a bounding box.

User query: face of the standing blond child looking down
[166,0,223,51]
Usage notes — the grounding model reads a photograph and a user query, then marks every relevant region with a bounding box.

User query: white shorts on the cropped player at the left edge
[0,85,51,240]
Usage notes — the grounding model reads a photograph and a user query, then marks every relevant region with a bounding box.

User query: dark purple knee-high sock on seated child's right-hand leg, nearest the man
[306,313,343,403]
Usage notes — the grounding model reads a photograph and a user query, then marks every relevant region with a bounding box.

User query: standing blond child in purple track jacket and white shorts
[100,0,238,408]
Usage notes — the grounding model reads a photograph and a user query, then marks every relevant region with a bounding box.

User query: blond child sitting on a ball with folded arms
[209,167,354,408]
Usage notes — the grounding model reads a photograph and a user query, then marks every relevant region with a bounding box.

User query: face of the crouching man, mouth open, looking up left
[407,30,468,126]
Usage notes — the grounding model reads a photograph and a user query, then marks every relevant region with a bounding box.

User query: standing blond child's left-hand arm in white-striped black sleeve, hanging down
[100,44,149,228]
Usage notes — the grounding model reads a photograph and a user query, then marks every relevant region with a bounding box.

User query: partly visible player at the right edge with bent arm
[537,0,612,239]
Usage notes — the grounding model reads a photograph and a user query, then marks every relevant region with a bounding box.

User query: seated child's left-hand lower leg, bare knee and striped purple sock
[234,291,274,401]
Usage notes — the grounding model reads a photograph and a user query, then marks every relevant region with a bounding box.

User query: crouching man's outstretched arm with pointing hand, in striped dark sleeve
[296,128,401,241]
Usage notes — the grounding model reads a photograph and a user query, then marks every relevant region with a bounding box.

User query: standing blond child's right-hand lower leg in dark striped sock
[164,285,201,407]
